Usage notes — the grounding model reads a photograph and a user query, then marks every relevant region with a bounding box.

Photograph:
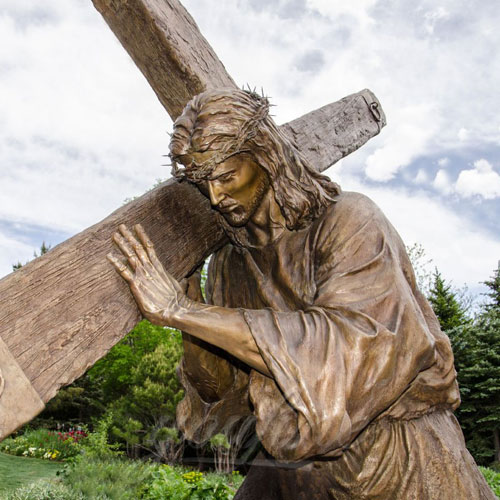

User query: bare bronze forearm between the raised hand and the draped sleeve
[168,301,270,376]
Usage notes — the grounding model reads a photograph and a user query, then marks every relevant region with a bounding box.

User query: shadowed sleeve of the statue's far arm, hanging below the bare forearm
[177,250,253,443]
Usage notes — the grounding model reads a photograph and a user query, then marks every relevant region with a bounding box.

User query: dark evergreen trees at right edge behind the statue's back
[429,264,500,465]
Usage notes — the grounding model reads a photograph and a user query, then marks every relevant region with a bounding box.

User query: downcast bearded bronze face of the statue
[203,153,269,227]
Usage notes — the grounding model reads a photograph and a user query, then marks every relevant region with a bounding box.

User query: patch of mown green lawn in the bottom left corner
[0,453,64,498]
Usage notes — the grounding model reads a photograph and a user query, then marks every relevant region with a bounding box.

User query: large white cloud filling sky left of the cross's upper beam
[0,0,171,232]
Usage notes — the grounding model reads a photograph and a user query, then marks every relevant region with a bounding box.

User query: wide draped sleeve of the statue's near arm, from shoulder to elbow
[242,197,435,461]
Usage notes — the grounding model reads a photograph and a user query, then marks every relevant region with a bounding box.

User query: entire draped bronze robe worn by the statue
[178,193,495,500]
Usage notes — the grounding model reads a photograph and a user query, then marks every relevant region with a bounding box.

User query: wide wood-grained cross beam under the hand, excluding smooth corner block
[0,181,224,402]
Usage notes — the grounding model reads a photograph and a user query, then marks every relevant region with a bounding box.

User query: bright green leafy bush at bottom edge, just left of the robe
[142,465,243,500]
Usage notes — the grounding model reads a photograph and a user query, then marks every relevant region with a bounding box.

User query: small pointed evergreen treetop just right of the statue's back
[428,269,469,332]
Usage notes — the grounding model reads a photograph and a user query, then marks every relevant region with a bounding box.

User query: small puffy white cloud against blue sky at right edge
[455,159,500,199]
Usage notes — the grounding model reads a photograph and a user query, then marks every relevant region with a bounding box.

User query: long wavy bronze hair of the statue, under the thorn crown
[170,89,340,241]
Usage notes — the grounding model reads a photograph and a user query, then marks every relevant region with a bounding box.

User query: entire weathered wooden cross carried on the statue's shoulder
[0,0,385,440]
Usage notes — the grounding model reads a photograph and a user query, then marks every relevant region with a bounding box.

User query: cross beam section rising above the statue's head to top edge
[92,0,236,119]
